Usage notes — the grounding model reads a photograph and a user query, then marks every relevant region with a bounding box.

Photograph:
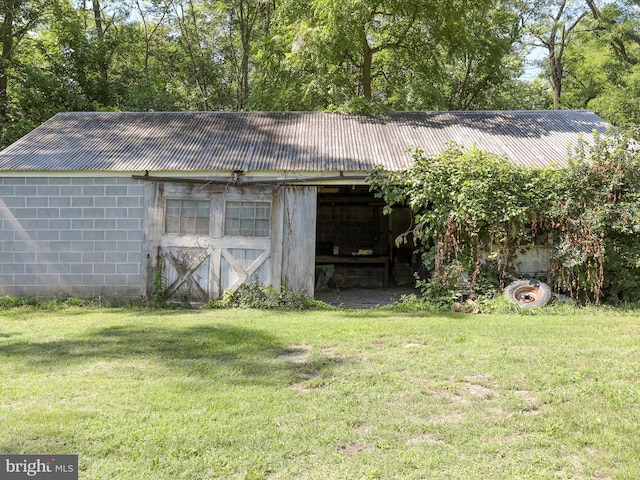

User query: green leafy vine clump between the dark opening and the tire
[368,144,558,299]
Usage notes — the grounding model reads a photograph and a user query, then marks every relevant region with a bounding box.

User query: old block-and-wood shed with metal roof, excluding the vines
[0,111,607,301]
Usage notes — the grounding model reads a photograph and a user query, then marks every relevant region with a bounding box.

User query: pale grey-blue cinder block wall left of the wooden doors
[0,175,145,300]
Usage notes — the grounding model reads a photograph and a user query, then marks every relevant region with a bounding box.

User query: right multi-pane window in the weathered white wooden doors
[224,202,271,237]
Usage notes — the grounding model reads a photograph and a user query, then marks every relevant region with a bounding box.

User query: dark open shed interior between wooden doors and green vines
[316,186,415,288]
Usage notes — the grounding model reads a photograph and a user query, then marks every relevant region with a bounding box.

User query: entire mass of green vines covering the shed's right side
[369,129,640,305]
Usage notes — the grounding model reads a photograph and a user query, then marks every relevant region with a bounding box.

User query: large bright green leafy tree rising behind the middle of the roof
[249,0,517,111]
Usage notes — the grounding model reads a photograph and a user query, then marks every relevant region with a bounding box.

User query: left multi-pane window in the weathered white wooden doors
[164,200,211,235]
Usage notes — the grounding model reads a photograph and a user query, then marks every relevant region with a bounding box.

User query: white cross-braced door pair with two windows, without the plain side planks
[161,186,279,302]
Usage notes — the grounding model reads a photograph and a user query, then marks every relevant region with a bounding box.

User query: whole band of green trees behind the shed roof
[0,0,640,146]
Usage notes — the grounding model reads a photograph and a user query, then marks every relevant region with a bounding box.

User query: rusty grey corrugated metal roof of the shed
[0,110,608,172]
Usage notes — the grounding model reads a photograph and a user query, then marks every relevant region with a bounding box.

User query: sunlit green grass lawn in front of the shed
[0,308,640,480]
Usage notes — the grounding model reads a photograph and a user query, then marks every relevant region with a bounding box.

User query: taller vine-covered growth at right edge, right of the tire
[549,133,640,304]
